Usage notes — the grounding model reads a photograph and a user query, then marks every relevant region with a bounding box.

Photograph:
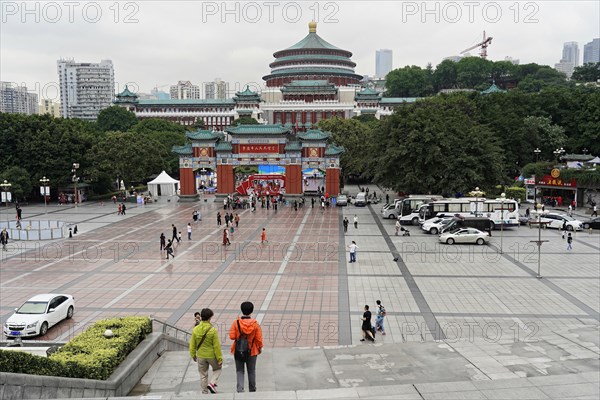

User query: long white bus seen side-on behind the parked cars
[419,197,519,229]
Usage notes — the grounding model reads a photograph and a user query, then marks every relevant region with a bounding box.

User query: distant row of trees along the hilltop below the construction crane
[386,57,600,97]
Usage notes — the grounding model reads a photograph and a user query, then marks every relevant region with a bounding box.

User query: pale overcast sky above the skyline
[0,0,600,97]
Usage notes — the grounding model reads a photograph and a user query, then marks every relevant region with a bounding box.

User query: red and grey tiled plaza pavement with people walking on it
[0,186,600,398]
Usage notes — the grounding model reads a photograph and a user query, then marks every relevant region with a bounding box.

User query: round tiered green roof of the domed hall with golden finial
[263,22,362,87]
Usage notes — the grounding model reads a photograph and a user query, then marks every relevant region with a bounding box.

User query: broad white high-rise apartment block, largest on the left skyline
[58,60,115,121]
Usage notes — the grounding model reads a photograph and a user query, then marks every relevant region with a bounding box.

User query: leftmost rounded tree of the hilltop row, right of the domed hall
[385,65,433,97]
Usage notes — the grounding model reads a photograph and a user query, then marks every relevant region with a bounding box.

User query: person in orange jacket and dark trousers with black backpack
[229,301,263,393]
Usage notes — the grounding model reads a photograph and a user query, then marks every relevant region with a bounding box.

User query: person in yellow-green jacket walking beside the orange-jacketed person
[190,308,223,394]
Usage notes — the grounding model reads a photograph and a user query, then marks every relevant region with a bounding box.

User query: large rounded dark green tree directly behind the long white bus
[368,96,503,195]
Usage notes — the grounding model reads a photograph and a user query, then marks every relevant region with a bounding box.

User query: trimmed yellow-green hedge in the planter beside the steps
[0,317,152,380]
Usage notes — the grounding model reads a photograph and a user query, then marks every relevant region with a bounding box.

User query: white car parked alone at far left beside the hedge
[3,293,75,337]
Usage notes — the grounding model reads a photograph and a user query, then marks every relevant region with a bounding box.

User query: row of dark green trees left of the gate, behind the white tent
[0,107,186,200]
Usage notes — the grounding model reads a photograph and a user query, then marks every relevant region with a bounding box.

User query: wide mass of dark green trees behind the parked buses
[319,87,600,195]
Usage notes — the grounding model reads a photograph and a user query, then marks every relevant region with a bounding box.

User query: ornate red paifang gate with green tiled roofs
[173,124,344,199]
